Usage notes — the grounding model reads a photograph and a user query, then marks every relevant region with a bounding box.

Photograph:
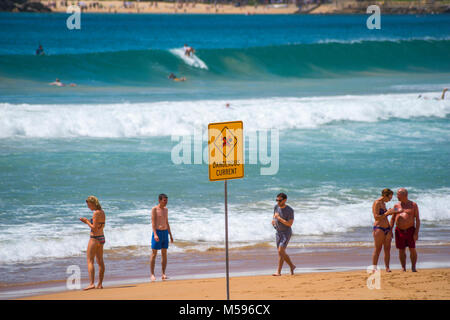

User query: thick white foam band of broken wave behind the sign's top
[0,92,450,138]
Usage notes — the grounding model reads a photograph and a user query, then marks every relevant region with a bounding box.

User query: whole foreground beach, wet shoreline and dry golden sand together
[5,246,450,299]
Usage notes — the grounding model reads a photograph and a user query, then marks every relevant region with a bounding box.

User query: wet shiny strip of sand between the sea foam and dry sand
[0,246,450,299]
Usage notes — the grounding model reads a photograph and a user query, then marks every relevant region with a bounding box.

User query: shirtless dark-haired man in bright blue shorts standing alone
[150,193,173,281]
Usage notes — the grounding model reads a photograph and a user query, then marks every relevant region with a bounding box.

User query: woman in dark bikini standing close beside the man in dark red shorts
[372,189,397,272]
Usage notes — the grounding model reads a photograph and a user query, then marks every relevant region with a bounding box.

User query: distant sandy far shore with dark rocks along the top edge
[12,0,450,15]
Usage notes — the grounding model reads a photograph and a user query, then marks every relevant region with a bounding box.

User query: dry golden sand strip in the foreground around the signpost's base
[20,269,450,300]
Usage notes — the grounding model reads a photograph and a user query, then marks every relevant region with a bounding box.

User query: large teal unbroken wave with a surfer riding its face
[0,39,450,85]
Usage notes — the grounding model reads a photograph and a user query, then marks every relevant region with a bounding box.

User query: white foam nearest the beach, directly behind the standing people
[0,188,450,263]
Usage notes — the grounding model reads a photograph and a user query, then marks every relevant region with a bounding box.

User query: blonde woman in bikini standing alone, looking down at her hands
[80,196,106,290]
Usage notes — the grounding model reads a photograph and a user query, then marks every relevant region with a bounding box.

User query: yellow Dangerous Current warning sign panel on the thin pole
[208,121,244,181]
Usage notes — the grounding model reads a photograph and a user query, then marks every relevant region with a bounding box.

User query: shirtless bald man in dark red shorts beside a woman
[390,188,420,272]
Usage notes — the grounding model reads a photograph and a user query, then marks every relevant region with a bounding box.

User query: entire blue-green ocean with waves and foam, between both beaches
[0,13,450,284]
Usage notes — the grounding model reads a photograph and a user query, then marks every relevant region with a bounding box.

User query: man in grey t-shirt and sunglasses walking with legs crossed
[272,193,295,276]
